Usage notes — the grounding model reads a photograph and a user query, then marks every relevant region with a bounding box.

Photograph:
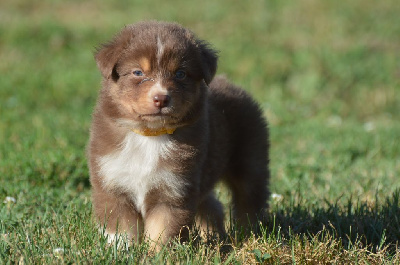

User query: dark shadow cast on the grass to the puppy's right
[267,190,400,252]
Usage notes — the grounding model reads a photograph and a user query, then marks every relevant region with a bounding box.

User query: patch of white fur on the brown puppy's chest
[98,132,184,215]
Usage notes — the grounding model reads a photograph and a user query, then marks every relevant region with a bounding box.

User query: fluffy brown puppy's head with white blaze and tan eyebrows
[95,22,217,130]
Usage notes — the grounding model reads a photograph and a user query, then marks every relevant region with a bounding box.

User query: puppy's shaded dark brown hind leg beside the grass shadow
[225,113,269,229]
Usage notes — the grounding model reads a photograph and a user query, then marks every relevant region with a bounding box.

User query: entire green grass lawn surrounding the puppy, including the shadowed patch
[0,0,400,264]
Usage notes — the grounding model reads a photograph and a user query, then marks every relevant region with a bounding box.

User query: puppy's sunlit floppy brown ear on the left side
[94,27,132,79]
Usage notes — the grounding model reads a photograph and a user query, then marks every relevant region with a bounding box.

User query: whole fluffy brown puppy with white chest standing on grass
[88,22,269,243]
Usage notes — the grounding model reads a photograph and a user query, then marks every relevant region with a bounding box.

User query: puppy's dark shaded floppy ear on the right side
[199,42,218,85]
